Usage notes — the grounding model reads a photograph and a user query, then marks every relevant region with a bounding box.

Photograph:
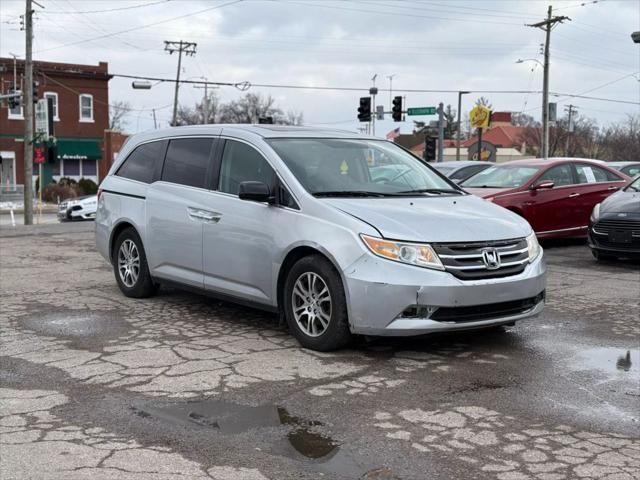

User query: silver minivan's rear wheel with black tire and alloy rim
[112,228,157,298]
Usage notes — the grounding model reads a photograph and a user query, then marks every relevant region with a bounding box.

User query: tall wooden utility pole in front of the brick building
[22,0,33,225]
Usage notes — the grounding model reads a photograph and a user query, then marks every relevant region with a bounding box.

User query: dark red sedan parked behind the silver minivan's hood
[461,158,629,238]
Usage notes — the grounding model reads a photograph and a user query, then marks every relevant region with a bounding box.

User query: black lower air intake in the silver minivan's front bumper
[431,292,544,323]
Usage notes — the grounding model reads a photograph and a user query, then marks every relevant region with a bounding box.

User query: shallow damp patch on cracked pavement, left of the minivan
[20,310,129,338]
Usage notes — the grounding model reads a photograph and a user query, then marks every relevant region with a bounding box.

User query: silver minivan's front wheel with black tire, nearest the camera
[283,255,351,352]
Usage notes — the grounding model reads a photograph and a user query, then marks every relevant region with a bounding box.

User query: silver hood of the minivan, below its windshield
[322,195,531,242]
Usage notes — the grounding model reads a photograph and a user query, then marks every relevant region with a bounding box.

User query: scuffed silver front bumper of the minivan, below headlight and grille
[343,252,546,336]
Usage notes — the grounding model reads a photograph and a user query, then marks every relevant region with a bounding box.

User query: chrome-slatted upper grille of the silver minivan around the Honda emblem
[431,238,529,280]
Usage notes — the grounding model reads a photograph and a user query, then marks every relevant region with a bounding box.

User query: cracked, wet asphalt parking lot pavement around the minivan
[0,223,640,480]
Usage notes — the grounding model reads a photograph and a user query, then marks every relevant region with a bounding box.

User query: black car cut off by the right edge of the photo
[589,176,640,260]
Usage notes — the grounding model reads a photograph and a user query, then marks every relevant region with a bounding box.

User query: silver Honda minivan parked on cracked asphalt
[96,125,546,351]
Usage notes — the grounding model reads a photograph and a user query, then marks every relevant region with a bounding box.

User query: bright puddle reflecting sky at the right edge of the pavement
[572,347,640,379]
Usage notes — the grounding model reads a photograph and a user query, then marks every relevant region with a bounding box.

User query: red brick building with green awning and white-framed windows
[0,58,111,187]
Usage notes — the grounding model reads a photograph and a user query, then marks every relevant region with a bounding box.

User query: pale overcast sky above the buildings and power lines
[0,0,640,135]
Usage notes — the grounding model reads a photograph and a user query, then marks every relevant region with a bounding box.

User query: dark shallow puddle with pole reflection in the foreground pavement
[132,400,395,479]
